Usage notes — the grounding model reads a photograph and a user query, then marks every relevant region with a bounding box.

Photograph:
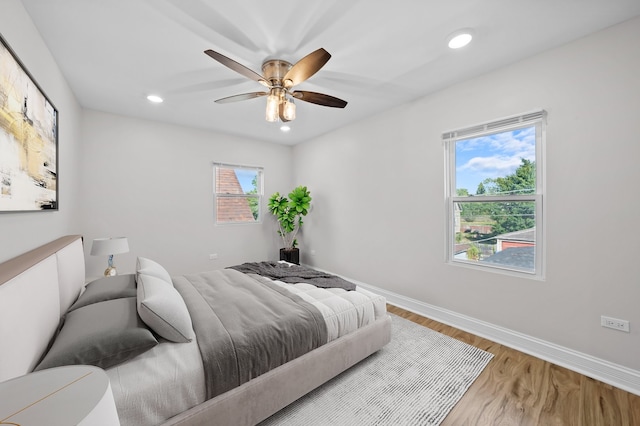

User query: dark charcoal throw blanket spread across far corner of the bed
[229,262,356,291]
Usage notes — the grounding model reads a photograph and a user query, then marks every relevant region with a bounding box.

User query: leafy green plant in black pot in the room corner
[269,186,311,264]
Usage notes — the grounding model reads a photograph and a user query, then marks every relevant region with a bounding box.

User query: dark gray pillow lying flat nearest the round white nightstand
[36,297,158,370]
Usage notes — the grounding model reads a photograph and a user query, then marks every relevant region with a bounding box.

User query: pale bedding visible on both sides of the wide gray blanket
[107,280,386,426]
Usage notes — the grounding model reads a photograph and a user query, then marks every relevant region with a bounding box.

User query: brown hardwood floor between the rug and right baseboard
[387,305,640,426]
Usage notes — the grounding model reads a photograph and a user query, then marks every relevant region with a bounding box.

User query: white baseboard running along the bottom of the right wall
[314,271,640,395]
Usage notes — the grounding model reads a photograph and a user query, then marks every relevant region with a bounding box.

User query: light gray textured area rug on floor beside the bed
[260,314,493,426]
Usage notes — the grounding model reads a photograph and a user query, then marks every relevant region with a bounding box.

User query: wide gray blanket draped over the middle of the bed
[173,269,327,398]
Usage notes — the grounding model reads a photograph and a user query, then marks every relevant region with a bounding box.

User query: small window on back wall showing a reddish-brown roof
[213,163,263,224]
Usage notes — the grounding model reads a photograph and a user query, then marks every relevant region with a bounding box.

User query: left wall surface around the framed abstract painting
[0,0,82,262]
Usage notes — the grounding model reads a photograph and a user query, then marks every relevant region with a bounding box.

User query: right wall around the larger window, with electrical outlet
[294,19,640,370]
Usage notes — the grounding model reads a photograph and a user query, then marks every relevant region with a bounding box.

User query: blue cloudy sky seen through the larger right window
[456,126,536,194]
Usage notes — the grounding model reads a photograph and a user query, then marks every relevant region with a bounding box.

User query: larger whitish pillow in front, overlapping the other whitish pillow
[137,273,194,343]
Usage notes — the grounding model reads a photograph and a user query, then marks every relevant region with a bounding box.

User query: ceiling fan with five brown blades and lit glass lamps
[204,48,347,122]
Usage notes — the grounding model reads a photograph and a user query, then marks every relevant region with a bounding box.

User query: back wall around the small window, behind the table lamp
[82,110,292,276]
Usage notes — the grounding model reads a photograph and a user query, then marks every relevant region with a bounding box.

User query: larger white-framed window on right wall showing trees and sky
[442,111,545,278]
